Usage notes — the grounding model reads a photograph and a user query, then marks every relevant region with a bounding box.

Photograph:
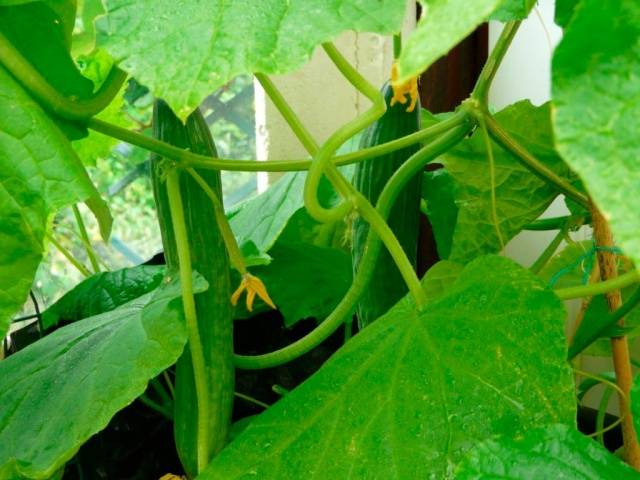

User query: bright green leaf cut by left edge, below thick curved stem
[0,68,108,338]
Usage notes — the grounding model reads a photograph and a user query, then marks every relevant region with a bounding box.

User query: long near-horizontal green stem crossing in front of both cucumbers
[87,118,451,172]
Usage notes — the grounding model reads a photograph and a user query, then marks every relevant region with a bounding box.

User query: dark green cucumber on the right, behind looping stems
[351,83,422,329]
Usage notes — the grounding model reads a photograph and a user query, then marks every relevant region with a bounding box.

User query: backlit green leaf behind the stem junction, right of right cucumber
[434,100,569,263]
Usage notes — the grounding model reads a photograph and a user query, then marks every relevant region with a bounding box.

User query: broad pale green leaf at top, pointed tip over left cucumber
[96,0,405,119]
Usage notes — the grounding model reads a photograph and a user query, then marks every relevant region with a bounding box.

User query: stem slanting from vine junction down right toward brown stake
[481,112,589,209]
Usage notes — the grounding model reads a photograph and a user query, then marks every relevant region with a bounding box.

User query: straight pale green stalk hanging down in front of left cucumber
[167,169,210,472]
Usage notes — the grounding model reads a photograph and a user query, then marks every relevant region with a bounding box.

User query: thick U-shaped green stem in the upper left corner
[0,33,127,120]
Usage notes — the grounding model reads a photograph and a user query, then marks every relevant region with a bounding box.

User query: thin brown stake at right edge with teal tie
[591,205,640,470]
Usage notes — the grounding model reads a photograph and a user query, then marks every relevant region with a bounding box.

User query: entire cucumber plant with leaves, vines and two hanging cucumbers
[0,0,640,480]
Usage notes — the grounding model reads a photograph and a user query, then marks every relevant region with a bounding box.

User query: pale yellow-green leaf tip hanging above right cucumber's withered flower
[398,0,502,82]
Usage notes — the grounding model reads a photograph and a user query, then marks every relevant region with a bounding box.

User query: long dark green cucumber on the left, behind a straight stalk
[151,100,234,478]
